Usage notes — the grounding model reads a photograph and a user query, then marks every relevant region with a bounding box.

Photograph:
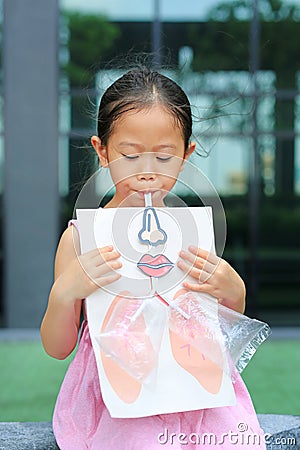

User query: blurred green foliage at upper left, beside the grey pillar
[65,12,119,86]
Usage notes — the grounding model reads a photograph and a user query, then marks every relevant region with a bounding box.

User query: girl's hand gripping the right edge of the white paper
[177,246,246,313]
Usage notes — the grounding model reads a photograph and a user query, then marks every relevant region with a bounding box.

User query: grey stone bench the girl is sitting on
[0,414,300,450]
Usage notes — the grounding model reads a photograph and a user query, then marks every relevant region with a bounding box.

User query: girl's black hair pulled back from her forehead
[97,67,192,149]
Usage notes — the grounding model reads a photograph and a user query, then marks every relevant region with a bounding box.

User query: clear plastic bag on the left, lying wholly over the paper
[96,297,167,384]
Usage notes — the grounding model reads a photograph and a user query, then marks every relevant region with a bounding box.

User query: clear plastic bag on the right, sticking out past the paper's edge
[169,292,271,380]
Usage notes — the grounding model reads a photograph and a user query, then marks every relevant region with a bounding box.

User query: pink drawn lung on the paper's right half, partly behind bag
[169,289,223,394]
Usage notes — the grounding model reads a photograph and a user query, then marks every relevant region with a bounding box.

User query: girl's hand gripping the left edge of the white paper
[56,245,122,302]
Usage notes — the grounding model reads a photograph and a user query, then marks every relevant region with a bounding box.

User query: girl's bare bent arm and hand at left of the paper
[41,226,121,359]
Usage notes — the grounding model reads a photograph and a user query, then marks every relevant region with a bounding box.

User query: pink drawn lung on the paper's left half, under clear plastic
[97,291,165,403]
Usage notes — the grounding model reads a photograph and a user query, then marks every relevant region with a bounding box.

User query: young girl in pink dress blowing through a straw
[41,68,265,450]
